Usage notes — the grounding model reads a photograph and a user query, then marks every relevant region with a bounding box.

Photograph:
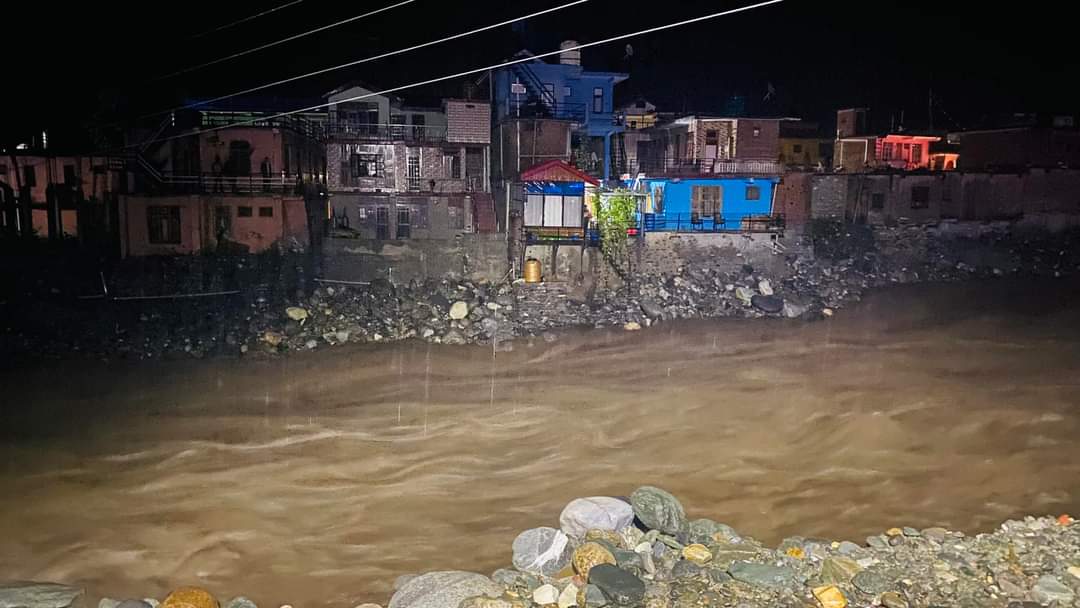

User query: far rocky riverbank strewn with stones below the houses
[0,224,1080,359]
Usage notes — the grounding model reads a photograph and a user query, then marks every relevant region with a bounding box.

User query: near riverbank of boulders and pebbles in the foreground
[0,486,1080,608]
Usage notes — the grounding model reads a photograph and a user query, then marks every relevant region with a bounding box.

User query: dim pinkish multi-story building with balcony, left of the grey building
[119,109,326,256]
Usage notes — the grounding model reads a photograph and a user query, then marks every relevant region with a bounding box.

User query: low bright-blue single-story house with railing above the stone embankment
[638,176,783,232]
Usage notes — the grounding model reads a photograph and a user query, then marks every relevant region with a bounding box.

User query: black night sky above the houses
[0,0,1078,146]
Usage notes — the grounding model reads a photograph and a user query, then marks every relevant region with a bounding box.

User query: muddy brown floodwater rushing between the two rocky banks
[0,281,1080,608]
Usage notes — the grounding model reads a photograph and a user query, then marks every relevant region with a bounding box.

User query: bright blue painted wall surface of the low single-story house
[643,177,780,230]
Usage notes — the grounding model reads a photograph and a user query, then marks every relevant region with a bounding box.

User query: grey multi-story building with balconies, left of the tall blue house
[326,84,495,240]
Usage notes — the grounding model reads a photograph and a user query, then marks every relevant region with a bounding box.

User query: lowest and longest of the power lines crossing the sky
[141,0,784,148]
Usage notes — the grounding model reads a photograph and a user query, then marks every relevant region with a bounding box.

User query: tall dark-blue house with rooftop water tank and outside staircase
[491,43,629,179]
